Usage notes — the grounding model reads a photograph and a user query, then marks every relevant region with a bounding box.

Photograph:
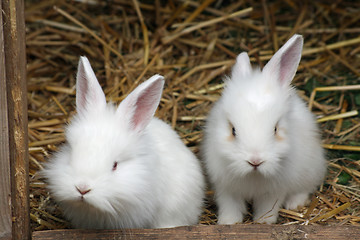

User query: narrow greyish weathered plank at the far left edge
[0,2,12,239]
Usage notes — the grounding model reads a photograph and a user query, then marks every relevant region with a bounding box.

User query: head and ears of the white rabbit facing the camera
[214,35,303,176]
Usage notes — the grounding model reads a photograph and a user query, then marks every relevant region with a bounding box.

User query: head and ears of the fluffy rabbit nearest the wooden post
[44,57,164,223]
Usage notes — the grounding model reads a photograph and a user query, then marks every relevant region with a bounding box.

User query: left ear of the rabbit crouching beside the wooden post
[76,57,106,113]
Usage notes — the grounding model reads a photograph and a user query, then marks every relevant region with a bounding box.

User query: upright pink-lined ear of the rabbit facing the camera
[263,34,303,86]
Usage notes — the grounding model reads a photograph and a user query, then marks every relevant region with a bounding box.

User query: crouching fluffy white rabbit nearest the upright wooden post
[42,57,204,229]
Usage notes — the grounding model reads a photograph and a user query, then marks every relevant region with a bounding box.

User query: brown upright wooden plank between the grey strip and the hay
[1,0,31,239]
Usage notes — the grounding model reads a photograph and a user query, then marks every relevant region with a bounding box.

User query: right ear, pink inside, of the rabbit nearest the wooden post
[117,74,164,132]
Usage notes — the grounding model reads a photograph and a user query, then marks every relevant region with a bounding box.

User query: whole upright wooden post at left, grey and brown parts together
[0,0,30,239]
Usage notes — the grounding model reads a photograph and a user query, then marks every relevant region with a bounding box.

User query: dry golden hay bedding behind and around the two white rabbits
[25,0,360,230]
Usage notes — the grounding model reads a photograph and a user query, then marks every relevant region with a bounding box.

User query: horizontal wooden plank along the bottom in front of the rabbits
[32,224,360,240]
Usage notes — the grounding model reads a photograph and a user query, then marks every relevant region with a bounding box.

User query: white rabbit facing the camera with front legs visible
[202,35,326,224]
